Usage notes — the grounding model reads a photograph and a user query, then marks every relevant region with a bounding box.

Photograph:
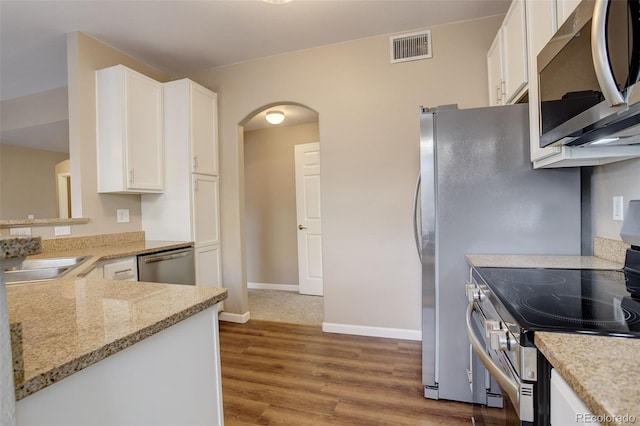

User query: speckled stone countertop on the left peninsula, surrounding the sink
[6,241,227,400]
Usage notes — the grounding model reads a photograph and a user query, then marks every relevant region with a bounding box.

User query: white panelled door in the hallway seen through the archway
[295,142,322,296]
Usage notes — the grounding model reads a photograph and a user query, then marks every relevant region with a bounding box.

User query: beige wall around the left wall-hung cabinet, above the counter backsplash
[67,32,169,235]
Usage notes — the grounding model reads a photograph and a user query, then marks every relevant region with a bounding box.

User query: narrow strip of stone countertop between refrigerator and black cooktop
[465,254,623,269]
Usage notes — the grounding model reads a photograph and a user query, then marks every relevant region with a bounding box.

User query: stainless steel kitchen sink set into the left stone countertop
[4,256,89,284]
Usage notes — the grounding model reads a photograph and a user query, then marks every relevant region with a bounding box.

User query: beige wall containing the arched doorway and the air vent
[190,17,502,331]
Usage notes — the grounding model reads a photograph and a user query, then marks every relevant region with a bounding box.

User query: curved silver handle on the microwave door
[591,0,626,107]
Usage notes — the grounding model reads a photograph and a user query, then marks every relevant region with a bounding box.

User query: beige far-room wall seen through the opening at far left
[0,145,69,220]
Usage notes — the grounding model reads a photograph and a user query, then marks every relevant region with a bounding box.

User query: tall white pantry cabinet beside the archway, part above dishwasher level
[141,79,220,248]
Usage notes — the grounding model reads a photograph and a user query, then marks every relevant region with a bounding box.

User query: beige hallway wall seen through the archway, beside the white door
[244,122,320,285]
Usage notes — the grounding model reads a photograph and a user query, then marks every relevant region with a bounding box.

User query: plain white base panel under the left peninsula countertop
[16,308,224,426]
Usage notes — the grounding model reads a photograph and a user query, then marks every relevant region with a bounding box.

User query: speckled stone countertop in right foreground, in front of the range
[535,332,640,425]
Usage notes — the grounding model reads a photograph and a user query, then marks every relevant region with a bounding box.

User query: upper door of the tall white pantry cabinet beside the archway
[191,83,218,176]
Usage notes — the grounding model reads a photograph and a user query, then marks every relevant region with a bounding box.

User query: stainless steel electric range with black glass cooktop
[467,247,640,425]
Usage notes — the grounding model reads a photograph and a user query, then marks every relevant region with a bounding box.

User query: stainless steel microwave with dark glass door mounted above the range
[537,0,640,147]
